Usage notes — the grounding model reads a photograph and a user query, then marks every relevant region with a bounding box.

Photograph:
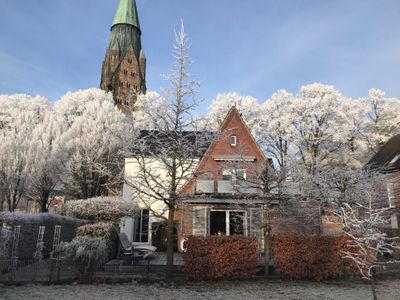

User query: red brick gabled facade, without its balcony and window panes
[175,107,269,250]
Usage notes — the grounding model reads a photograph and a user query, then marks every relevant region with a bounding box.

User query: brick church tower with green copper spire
[100,0,146,112]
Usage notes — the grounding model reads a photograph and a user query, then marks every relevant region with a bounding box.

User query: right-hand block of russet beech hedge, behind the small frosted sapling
[272,234,354,280]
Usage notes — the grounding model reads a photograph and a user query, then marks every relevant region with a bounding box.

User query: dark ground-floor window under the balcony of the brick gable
[209,210,246,235]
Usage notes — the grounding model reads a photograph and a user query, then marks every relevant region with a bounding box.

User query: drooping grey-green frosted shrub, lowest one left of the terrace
[58,236,107,276]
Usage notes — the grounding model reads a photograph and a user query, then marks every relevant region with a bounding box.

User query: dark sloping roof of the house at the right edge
[367,134,400,173]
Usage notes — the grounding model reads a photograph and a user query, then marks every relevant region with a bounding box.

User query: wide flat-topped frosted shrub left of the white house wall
[64,197,137,222]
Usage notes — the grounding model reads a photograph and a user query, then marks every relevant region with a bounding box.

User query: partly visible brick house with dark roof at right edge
[367,135,400,235]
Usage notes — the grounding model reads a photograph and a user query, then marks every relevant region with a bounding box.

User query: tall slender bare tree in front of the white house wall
[126,24,212,279]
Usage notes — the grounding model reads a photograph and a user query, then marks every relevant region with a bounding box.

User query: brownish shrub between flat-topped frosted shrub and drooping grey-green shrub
[76,222,118,259]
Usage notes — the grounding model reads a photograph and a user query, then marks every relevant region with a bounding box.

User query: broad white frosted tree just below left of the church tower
[55,89,131,199]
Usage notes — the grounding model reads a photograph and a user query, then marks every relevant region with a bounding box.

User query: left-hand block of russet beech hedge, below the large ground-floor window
[183,236,259,280]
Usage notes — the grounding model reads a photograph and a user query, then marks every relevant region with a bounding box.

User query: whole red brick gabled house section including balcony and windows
[176,107,273,250]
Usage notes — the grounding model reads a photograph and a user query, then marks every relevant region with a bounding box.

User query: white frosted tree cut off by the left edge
[0,94,49,211]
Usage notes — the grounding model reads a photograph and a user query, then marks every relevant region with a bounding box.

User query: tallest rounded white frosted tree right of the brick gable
[289,83,348,174]
